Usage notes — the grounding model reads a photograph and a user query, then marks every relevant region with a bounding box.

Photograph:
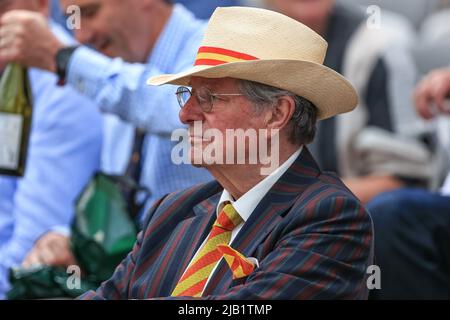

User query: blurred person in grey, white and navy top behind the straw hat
[264,0,431,203]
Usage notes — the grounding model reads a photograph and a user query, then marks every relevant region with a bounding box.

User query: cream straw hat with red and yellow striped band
[148,7,358,119]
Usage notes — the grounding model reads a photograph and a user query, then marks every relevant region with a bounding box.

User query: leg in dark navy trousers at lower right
[367,189,450,299]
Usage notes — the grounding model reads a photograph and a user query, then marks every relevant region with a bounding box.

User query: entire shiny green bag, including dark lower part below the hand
[8,173,150,299]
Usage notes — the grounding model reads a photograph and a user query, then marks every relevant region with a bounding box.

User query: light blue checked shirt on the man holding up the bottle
[67,4,212,219]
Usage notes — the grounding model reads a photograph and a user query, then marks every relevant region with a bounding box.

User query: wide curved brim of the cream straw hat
[147,60,358,120]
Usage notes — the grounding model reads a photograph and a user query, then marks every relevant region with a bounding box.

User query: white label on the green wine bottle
[0,112,23,170]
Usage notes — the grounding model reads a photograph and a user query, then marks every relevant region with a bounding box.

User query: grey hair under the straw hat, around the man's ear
[238,79,318,145]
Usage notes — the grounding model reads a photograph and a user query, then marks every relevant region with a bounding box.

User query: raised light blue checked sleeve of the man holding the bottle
[67,46,186,136]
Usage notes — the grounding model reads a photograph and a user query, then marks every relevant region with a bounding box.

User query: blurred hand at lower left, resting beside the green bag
[22,232,78,268]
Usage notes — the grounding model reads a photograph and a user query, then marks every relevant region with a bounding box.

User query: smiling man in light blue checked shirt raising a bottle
[0,0,211,265]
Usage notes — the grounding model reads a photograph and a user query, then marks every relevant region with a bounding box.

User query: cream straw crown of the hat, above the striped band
[201,7,328,64]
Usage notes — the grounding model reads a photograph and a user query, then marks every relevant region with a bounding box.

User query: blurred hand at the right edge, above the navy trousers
[414,68,450,119]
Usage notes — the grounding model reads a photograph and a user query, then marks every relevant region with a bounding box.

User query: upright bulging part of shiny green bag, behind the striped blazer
[71,173,148,281]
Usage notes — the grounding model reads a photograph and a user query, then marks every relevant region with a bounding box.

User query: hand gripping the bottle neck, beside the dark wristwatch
[0,10,64,72]
